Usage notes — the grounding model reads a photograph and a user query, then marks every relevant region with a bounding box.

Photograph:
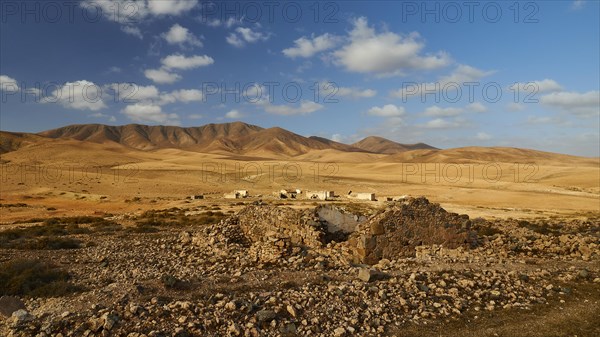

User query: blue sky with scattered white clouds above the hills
[0,0,600,156]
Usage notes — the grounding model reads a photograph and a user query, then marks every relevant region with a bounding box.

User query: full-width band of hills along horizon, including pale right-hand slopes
[0,122,598,165]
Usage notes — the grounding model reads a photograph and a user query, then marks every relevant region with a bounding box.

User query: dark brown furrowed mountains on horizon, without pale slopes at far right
[0,122,436,157]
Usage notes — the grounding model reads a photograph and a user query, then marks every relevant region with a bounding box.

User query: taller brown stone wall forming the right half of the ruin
[347,198,476,264]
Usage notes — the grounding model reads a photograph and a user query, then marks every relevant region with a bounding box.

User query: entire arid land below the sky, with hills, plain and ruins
[0,122,600,336]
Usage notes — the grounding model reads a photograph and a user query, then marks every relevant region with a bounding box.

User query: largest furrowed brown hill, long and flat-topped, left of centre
[32,122,365,157]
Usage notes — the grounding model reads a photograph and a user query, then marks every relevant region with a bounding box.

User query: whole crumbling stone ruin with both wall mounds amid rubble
[194,198,477,264]
